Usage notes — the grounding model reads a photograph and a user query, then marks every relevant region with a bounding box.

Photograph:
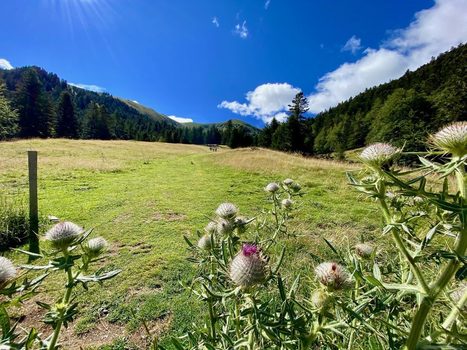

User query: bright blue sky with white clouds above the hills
[0,0,467,126]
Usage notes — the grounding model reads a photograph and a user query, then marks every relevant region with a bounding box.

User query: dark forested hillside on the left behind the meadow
[0,67,257,147]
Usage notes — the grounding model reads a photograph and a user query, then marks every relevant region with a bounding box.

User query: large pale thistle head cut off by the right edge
[430,122,467,157]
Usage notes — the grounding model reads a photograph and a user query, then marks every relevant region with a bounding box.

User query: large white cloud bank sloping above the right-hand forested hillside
[308,0,467,113]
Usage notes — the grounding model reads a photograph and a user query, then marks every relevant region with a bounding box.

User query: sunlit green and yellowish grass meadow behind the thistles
[0,140,382,349]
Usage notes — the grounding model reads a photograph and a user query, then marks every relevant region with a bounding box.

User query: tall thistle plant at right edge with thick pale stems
[348,122,467,350]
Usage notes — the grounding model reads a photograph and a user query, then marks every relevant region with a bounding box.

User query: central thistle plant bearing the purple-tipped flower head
[179,185,306,350]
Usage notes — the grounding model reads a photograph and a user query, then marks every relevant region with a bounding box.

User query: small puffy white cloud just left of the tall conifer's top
[217,83,300,123]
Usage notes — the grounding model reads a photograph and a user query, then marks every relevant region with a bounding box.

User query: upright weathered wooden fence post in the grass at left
[28,151,39,260]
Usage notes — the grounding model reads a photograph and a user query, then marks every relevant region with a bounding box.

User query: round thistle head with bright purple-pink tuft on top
[230,244,266,288]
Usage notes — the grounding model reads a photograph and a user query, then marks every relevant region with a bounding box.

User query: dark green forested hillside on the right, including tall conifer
[259,45,467,154]
